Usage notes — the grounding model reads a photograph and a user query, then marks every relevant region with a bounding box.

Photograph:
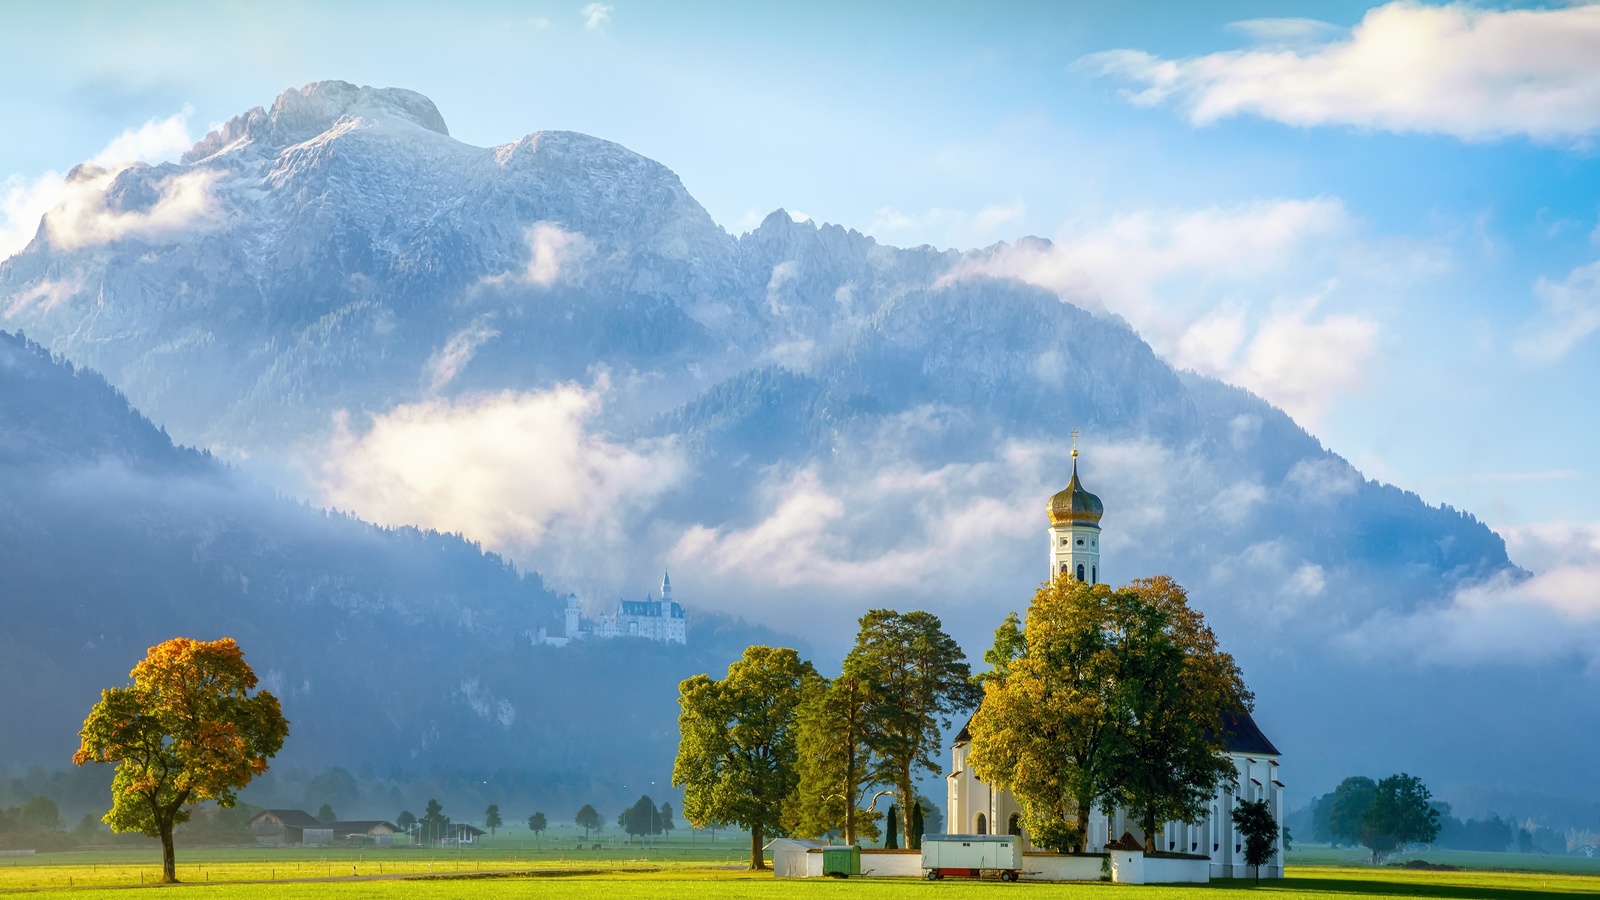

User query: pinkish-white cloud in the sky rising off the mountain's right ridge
[946,199,1378,426]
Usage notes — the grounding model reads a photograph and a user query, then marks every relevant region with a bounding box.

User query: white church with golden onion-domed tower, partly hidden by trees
[946,432,1283,878]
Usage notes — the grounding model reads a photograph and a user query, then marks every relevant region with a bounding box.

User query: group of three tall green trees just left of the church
[672,610,981,870]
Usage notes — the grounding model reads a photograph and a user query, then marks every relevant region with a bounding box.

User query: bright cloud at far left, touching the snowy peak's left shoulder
[0,109,195,259]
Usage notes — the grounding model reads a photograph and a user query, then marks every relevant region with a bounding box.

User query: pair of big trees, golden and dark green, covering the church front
[968,577,1253,852]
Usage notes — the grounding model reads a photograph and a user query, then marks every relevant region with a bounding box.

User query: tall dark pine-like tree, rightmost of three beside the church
[846,610,982,833]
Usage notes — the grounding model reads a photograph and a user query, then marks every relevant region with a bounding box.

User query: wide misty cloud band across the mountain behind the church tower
[667,408,1358,641]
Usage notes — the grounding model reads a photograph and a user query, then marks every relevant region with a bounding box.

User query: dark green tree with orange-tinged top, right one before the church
[1107,575,1251,836]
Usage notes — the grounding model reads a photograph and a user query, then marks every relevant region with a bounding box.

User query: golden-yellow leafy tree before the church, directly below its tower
[966,577,1122,850]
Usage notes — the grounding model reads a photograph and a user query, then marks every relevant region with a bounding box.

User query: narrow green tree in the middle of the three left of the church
[784,658,882,844]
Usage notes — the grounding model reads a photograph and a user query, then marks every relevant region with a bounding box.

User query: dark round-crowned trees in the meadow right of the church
[1312,772,1446,863]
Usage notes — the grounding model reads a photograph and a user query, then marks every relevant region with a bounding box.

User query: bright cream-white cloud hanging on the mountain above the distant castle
[322,384,683,549]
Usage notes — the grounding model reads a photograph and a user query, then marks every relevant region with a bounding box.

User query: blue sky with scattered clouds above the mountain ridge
[0,0,1600,569]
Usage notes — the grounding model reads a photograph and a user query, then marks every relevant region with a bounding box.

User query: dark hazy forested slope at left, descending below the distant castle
[0,323,780,814]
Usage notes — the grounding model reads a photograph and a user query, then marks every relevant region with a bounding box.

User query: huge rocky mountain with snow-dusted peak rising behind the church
[0,82,1568,794]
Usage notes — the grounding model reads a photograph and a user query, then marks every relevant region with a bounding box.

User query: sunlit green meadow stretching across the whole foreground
[0,831,1600,900]
